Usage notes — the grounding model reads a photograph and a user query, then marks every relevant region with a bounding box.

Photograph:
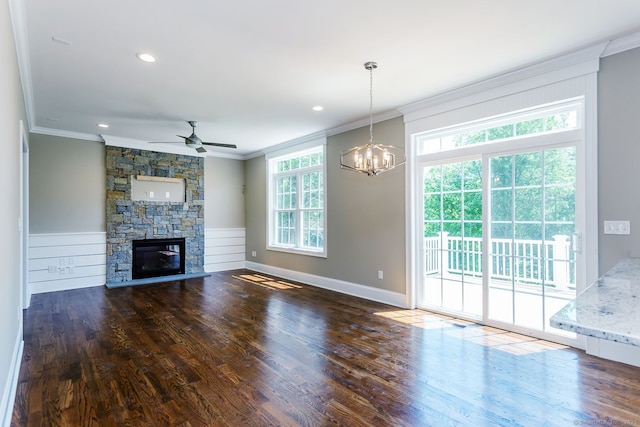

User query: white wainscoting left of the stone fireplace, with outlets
[29,233,107,294]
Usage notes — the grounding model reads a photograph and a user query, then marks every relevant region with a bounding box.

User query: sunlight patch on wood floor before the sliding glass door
[375,310,568,356]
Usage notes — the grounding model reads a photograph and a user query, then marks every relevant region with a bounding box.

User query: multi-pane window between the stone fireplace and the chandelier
[267,144,326,256]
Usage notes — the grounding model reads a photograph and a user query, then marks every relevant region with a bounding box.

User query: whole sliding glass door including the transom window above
[415,101,585,340]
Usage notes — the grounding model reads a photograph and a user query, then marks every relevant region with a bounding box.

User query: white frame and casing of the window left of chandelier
[266,138,327,258]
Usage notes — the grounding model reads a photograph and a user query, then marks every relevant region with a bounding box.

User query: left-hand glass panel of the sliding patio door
[423,160,482,318]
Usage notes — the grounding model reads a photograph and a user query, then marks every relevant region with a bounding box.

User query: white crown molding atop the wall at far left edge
[9,0,35,130]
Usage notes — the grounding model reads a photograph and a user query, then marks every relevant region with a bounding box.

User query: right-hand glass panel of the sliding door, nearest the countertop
[486,147,577,333]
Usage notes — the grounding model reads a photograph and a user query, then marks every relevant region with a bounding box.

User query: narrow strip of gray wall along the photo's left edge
[0,1,27,423]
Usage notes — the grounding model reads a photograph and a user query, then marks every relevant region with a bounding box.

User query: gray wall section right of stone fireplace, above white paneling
[204,157,245,228]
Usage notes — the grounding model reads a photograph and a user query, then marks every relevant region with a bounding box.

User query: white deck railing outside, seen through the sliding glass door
[424,232,576,289]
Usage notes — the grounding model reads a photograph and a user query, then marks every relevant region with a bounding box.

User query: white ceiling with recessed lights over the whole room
[12,0,640,156]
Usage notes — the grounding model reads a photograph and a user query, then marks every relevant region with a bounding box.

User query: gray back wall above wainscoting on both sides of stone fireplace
[29,134,245,234]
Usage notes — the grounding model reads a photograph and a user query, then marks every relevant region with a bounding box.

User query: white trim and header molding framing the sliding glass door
[400,46,604,348]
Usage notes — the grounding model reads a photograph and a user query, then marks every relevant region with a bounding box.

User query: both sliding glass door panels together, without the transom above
[419,146,576,340]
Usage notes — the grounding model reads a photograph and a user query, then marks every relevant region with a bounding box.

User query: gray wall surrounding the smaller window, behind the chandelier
[245,117,406,293]
